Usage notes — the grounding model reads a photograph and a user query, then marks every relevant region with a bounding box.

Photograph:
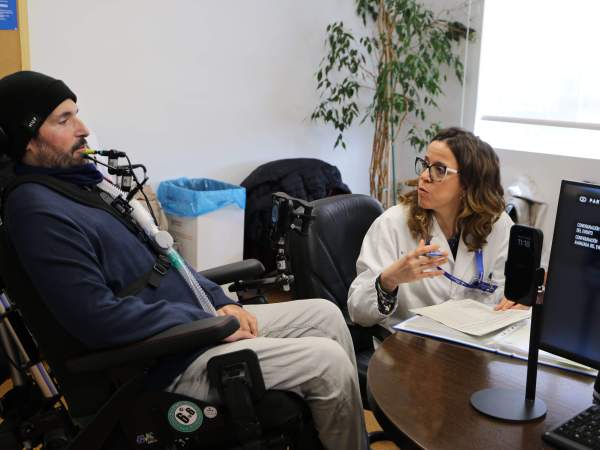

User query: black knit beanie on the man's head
[0,71,77,161]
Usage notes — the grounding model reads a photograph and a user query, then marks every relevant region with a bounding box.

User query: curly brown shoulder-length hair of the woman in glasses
[400,127,505,251]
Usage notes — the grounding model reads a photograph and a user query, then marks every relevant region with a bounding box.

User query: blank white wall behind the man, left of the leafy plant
[28,0,372,193]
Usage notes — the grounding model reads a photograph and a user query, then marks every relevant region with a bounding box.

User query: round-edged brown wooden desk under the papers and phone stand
[367,332,594,450]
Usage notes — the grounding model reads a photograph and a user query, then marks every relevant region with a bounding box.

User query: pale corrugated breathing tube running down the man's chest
[98,180,217,316]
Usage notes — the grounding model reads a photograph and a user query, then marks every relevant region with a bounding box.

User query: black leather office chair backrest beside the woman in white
[288,194,383,313]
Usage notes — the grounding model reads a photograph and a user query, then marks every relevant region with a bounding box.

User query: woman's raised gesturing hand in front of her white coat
[380,239,448,292]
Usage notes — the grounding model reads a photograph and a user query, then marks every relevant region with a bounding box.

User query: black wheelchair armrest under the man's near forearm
[66,316,240,373]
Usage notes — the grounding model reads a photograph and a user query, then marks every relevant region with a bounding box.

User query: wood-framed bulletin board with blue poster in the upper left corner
[0,0,30,77]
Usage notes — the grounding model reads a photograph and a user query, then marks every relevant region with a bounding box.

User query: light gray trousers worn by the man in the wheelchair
[167,299,368,450]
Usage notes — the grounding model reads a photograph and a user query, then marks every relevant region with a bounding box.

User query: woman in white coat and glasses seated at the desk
[348,128,514,328]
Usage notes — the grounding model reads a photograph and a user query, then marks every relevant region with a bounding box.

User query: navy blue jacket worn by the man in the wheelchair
[5,179,235,386]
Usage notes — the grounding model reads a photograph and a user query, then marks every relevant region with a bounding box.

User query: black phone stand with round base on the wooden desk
[471,268,548,422]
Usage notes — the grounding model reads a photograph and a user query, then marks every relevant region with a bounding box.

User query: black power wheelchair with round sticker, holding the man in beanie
[0,236,322,450]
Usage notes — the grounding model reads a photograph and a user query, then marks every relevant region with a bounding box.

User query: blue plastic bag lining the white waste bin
[156,177,246,217]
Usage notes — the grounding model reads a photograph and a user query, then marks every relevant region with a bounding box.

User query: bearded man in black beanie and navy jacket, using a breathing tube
[0,72,367,450]
